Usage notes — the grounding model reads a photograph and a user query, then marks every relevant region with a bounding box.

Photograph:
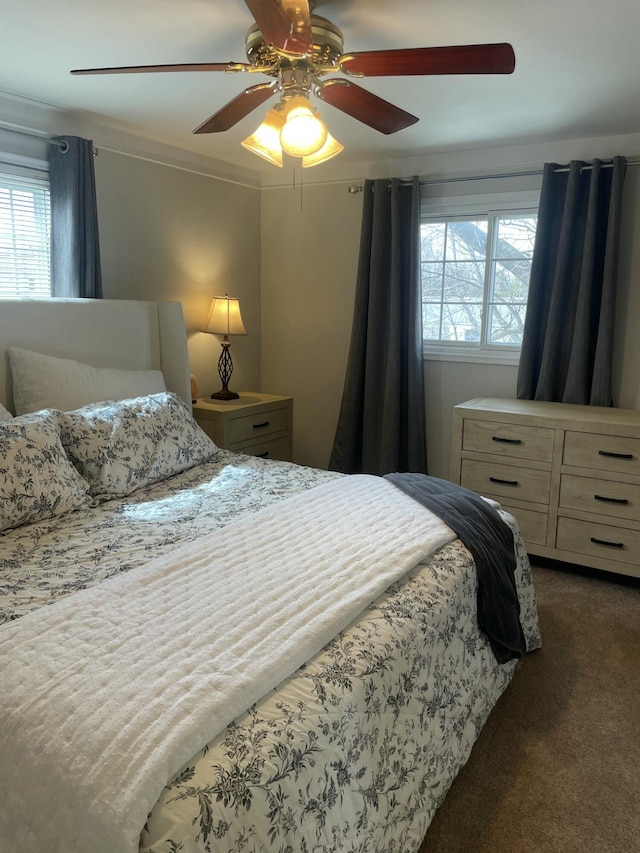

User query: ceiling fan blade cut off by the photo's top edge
[245,0,313,56]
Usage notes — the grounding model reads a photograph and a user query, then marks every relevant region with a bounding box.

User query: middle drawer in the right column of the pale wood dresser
[560,474,640,521]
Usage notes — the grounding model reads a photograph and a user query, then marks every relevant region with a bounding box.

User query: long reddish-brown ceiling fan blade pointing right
[341,43,516,77]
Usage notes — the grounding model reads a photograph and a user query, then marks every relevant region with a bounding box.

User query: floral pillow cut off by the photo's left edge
[0,411,90,530]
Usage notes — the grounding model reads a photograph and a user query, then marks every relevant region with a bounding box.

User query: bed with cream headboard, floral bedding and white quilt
[0,300,540,853]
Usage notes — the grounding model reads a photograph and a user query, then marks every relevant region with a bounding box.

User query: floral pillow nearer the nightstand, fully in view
[59,392,219,500]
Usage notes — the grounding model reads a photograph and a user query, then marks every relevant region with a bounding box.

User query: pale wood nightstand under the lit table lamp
[193,391,293,462]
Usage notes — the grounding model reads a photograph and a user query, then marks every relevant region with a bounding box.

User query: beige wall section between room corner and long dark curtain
[262,184,362,468]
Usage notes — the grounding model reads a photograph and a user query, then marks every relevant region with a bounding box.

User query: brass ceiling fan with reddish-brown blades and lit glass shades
[71,0,515,166]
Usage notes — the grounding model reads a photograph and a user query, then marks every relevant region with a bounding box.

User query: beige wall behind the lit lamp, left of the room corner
[95,150,261,396]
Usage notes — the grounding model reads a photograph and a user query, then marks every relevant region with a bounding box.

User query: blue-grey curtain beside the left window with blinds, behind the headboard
[49,136,102,299]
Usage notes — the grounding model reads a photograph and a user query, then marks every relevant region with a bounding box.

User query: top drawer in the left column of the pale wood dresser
[462,418,553,462]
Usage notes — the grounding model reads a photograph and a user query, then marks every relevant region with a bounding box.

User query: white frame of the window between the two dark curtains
[421,190,540,365]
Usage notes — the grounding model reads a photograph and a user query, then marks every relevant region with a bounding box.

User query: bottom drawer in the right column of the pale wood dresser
[556,518,640,565]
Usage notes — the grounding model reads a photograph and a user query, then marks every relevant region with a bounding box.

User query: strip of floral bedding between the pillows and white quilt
[0,450,338,623]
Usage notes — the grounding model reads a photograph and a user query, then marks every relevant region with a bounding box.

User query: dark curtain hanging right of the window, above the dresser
[517,157,626,406]
